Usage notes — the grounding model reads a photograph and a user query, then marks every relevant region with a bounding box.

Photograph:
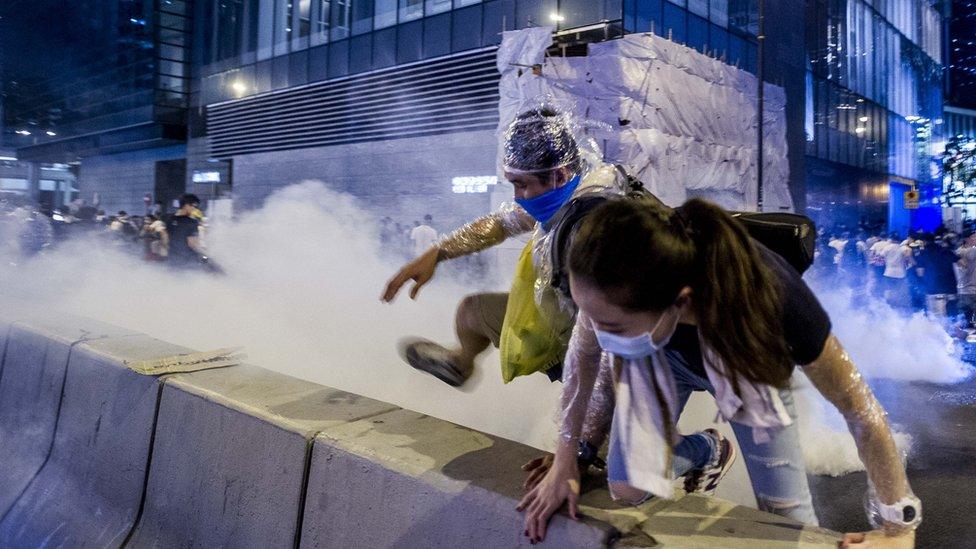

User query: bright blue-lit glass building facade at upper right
[807,0,942,186]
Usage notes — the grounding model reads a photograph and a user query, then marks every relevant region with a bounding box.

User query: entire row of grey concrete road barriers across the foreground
[0,312,837,549]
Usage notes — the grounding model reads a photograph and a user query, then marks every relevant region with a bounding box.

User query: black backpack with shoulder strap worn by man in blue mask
[550,165,817,296]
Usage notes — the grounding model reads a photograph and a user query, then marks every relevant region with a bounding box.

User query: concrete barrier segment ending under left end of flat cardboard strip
[0,335,187,548]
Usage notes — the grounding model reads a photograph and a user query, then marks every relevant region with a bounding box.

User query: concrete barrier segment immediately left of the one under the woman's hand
[132,365,396,549]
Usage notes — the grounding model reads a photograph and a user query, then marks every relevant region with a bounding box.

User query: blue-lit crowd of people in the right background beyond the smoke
[810,223,976,326]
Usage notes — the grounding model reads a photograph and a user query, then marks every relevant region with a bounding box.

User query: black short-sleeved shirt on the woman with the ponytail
[664,241,831,378]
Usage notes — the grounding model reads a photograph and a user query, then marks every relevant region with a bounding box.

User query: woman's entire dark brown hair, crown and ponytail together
[569,198,792,392]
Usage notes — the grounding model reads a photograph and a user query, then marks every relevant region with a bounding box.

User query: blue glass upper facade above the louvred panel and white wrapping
[196,0,758,104]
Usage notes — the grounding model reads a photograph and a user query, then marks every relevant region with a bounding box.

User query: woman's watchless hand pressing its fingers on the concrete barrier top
[516,456,580,543]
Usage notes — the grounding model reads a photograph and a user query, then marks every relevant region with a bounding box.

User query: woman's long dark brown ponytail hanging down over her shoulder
[680,199,792,391]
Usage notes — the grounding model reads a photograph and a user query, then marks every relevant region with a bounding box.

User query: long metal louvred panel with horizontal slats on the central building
[207,48,499,158]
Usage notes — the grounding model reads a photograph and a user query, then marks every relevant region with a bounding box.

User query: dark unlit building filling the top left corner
[2,0,189,162]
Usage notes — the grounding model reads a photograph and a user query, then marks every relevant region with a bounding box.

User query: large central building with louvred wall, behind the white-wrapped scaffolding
[187,0,804,225]
